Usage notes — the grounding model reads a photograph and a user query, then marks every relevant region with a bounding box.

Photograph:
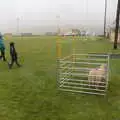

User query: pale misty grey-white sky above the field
[0,0,117,32]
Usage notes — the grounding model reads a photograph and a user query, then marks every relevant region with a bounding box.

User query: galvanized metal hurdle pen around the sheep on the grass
[57,52,110,95]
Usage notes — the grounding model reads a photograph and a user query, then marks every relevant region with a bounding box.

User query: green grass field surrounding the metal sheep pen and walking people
[0,36,120,120]
